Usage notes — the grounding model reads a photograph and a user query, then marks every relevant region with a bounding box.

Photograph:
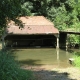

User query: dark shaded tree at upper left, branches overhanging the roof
[0,0,29,35]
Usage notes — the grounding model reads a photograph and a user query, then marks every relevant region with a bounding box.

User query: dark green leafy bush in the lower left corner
[0,51,34,80]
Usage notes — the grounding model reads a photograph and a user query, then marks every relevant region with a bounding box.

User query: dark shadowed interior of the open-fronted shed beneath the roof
[5,35,56,47]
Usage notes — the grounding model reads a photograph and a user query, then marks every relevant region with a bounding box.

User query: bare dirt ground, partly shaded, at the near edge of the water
[24,65,80,80]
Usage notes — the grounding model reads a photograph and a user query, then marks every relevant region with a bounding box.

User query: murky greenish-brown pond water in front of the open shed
[14,48,73,67]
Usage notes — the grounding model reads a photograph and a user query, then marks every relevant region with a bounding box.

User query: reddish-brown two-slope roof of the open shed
[7,16,59,34]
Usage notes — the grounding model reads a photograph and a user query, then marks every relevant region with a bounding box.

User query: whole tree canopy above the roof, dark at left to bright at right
[0,0,80,30]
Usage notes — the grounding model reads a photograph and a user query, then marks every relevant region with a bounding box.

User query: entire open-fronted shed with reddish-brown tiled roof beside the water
[2,16,59,48]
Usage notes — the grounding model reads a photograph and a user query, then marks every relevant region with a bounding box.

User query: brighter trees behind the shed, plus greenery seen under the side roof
[21,0,80,44]
